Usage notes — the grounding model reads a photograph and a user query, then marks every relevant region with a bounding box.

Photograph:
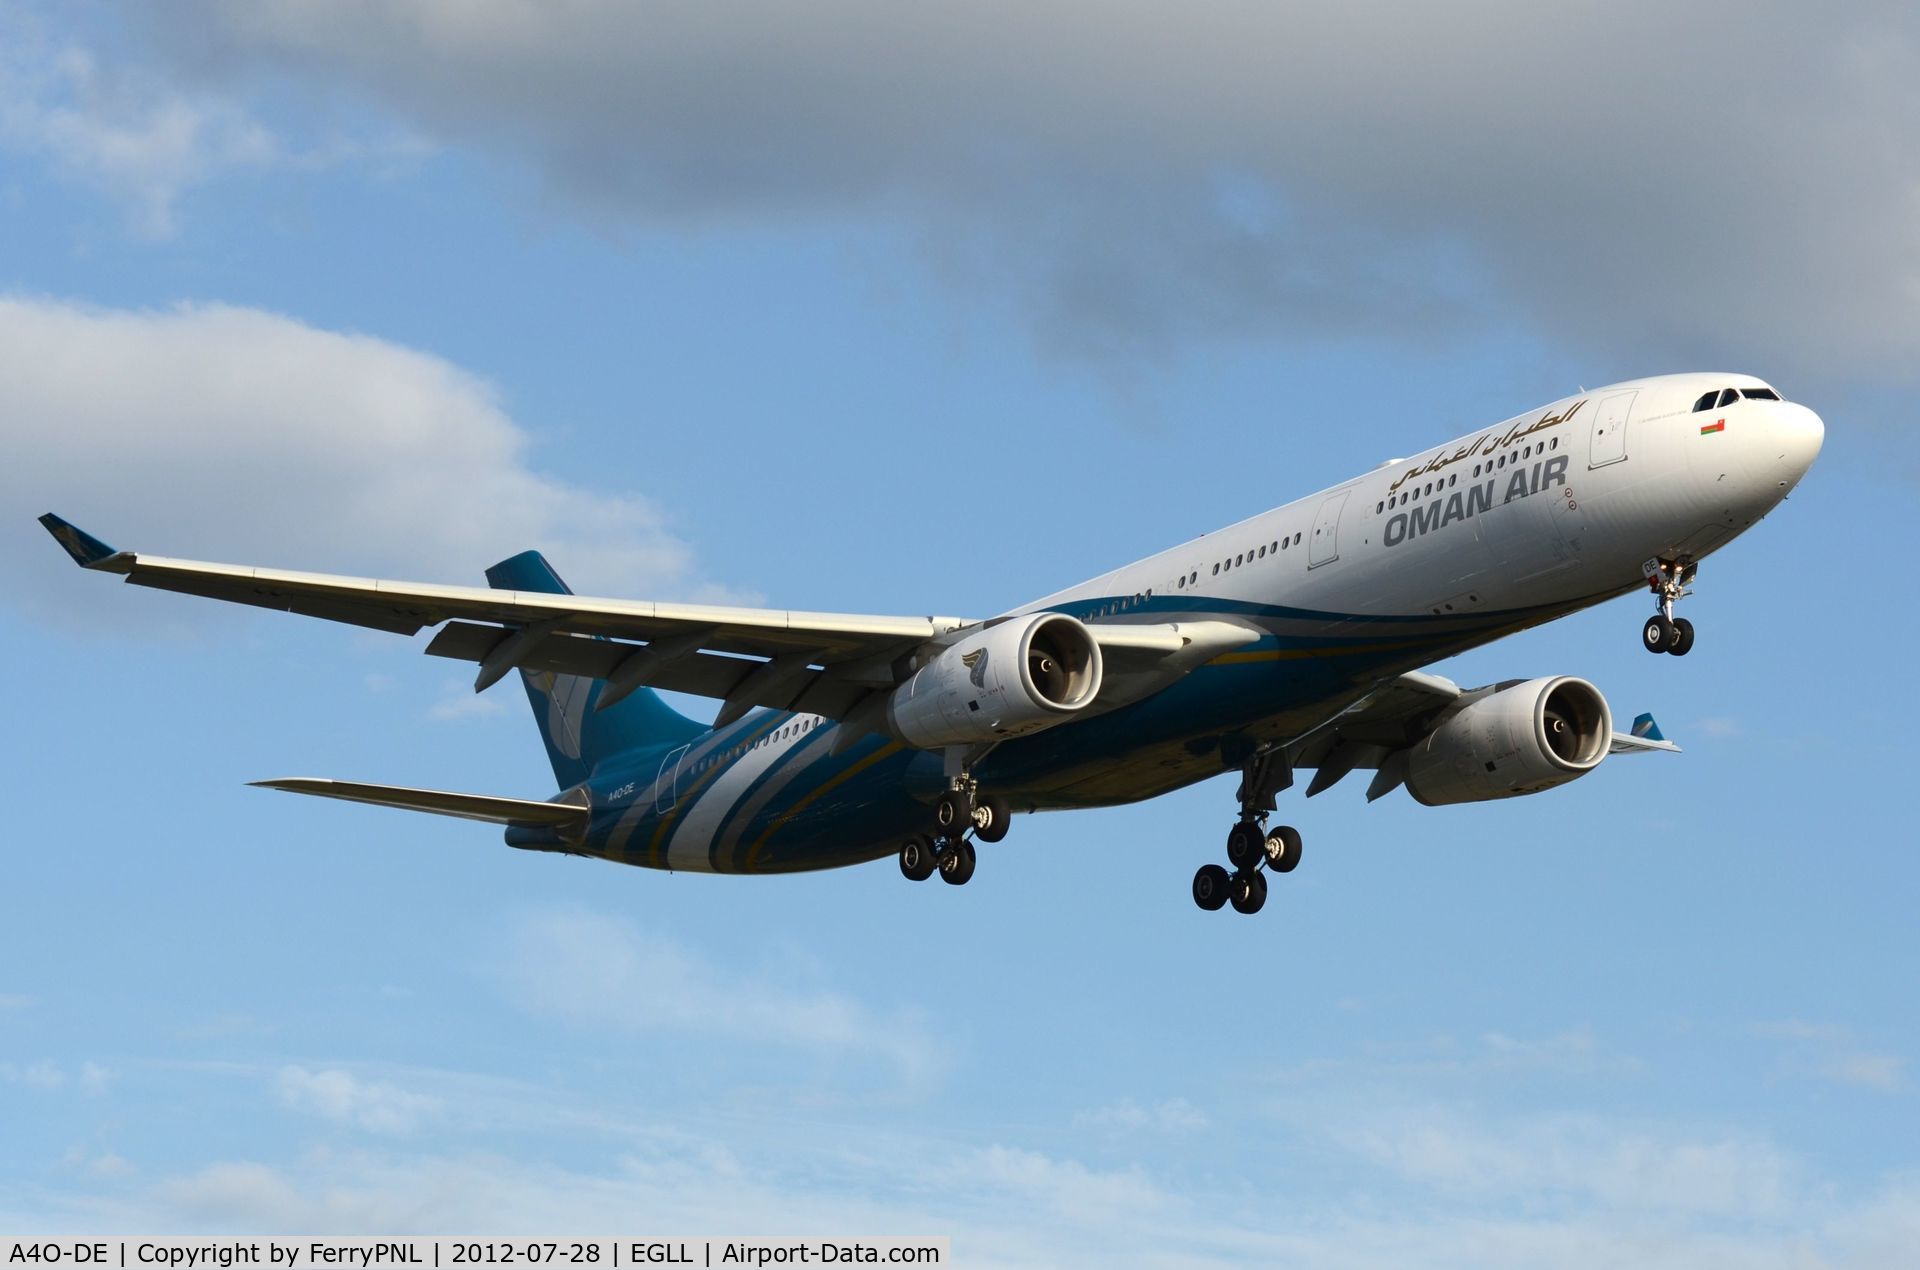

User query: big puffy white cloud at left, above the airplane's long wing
[0,296,721,615]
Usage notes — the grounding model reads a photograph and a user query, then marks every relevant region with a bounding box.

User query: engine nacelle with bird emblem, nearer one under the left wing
[887,613,1100,749]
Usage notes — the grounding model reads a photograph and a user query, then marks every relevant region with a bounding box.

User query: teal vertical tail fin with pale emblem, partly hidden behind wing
[486,551,707,790]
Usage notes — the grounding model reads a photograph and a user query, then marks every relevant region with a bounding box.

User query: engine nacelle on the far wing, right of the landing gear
[1407,674,1613,807]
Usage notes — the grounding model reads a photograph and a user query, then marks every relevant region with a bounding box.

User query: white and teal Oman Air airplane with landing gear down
[40,373,1824,913]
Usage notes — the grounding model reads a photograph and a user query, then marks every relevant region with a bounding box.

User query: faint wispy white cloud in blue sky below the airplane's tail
[505,909,945,1084]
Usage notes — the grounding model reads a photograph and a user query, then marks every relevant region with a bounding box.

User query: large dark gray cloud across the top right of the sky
[131,0,1920,380]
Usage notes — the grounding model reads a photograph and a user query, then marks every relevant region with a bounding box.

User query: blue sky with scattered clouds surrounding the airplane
[0,0,1920,1266]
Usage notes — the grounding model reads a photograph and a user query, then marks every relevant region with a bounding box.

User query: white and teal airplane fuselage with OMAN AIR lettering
[607,375,1824,872]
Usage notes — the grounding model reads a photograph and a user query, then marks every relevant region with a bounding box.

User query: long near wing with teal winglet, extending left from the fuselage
[40,513,1256,726]
